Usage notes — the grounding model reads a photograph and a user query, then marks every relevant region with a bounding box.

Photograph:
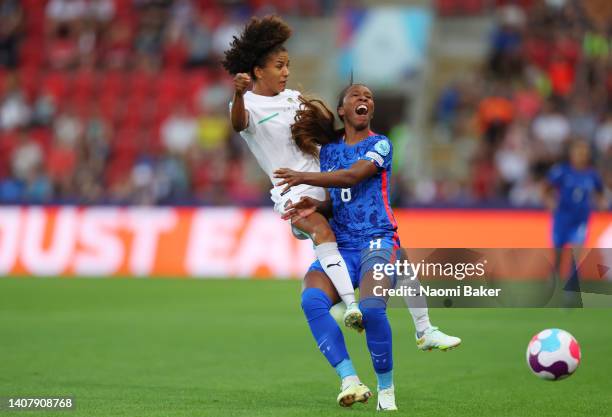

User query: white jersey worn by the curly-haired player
[232,89,324,208]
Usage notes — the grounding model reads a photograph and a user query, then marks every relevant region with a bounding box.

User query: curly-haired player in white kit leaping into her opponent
[223,16,362,330]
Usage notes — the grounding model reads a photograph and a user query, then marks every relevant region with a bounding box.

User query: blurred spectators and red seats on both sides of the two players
[0,0,612,206]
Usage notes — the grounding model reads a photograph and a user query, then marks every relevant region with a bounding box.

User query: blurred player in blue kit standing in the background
[544,140,606,296]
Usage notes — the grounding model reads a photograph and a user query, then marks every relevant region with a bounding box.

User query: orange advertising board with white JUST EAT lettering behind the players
[0,207,612,278]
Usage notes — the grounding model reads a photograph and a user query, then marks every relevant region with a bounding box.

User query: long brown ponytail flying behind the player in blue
[291,97,344,158]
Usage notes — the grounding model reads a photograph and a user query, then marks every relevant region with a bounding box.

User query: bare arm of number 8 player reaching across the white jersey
[274,159,378,193]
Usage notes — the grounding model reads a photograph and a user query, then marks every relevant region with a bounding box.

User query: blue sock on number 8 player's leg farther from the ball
[302,288,355,373]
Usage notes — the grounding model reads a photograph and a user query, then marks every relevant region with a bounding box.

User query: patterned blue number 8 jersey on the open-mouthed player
[320,134,399,249]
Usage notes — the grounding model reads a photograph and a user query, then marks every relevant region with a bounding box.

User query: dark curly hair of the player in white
[222,15,291,78]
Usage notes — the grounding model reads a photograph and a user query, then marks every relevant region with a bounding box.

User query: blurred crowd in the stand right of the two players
[430,0,612,206]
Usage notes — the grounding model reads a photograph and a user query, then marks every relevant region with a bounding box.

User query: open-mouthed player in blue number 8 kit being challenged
[275,84,461,410]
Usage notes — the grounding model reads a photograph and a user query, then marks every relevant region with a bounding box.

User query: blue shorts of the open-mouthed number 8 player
[308,237,400,288]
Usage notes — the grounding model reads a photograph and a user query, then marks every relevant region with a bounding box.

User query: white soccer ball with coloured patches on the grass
[527,329,580,381]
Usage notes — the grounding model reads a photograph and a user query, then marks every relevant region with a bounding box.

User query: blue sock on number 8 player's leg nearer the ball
[359,297,393,390]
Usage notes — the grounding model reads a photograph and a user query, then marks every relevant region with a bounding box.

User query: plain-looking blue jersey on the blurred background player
[548,164,603,221]
